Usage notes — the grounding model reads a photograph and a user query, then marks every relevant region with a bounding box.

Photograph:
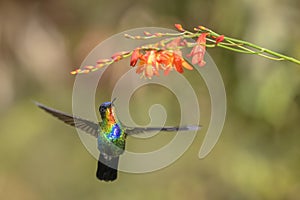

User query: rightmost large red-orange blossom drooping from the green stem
[187,33,209,67]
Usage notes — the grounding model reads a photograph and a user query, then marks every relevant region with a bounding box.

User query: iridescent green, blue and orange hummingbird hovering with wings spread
[35,99,201,182]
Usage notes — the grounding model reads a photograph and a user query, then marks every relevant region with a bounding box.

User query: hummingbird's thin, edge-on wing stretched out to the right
[125,126,201,135]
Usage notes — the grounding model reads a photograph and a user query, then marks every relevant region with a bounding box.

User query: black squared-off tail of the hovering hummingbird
[96,153,119,181]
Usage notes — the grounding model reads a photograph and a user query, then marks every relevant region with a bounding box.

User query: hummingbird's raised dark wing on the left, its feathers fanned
[35,102,100,137]
